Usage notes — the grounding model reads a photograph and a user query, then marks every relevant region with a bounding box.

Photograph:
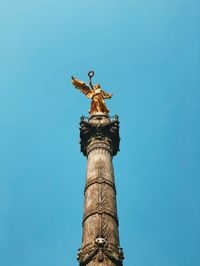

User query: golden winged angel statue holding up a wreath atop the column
[72,71,112,114]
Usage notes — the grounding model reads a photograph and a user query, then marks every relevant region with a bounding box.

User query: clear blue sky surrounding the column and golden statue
[0,0,200,266]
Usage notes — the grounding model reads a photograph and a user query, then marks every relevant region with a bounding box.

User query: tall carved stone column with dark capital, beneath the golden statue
[77,113,124,266]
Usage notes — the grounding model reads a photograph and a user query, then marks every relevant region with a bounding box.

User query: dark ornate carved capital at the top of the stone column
[80,116,120,156]
